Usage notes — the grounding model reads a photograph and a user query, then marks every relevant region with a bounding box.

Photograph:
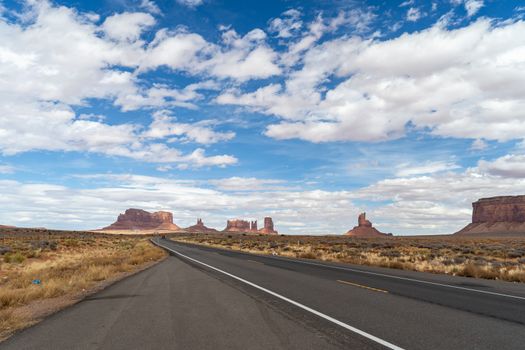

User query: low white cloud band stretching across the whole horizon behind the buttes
[4,163,525,235]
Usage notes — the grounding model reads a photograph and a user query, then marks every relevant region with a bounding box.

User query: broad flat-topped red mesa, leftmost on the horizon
[102,209,180,231]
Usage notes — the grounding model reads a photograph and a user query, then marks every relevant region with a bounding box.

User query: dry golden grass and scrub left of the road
[0,229,165,340]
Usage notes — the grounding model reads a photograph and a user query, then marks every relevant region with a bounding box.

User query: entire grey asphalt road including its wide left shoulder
[0,239,525,350]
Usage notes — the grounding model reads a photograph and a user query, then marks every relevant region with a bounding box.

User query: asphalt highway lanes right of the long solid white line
[154,240,525,349]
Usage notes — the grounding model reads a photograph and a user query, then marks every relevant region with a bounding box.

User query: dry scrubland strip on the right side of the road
[172,234,525,282]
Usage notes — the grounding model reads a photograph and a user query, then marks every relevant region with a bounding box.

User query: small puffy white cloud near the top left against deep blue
[102,12,155,42]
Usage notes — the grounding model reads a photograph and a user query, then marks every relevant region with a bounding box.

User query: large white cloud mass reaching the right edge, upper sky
[217,19,525,142]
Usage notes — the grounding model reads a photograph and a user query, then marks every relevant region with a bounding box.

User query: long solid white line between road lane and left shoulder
[151,240,404,350]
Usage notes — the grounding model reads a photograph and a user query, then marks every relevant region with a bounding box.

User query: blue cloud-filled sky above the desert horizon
[0,0,525,235]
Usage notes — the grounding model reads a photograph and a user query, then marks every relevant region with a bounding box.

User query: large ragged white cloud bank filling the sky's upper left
[0,1,237,167]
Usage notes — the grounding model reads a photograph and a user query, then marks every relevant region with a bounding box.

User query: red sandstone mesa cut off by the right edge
[456,195,525,235]
